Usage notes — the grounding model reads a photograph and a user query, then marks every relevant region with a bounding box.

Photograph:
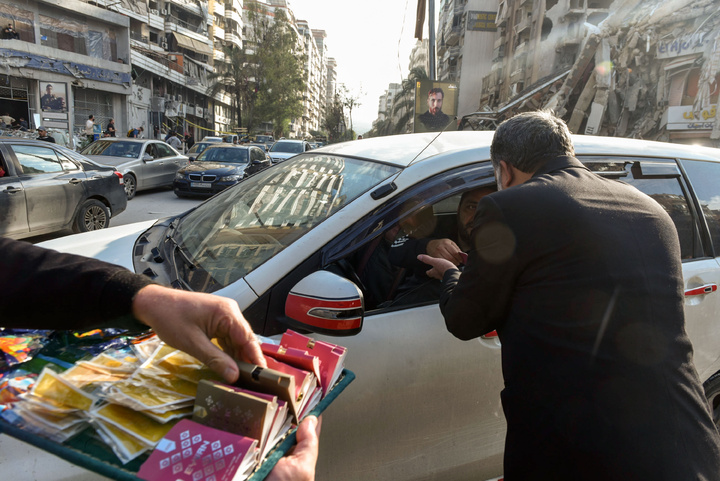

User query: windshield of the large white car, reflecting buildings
[173,154,399,290]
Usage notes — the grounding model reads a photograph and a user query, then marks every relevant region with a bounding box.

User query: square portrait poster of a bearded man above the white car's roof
[414,79,458,132]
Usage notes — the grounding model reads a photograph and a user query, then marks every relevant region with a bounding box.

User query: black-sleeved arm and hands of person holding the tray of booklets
[0,237,320,481]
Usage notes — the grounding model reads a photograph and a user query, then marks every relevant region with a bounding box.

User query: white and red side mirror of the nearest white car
[285,271,365,336]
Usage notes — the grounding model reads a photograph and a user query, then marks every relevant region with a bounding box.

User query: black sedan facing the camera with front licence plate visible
[173,143,271,197]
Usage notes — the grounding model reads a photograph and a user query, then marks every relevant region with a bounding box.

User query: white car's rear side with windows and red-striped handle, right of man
[580,156,720,381]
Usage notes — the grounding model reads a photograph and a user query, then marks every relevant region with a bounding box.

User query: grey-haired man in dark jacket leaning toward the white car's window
[419,112,720,481]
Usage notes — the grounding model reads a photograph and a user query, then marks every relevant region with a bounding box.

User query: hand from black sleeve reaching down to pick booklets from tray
[132,284,267,384]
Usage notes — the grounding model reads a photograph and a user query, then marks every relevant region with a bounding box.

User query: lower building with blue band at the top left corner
[0,0,134,144]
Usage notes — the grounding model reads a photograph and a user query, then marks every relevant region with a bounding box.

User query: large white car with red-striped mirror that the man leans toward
[35,132,720,481]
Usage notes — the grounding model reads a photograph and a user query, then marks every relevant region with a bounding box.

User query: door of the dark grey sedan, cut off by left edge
[0,146,30,237]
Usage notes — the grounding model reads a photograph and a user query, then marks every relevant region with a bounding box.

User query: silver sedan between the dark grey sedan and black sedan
[81,137,188,200]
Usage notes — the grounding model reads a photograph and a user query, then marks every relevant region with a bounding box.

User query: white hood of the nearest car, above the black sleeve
[37,220,157,272]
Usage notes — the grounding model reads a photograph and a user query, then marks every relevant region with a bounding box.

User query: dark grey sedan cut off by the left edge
[0,138,127,239]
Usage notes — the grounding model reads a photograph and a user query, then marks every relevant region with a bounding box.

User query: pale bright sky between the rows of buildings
[288,0,422,134]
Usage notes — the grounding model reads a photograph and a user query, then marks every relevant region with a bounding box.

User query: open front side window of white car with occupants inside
[326,162,495,312]
